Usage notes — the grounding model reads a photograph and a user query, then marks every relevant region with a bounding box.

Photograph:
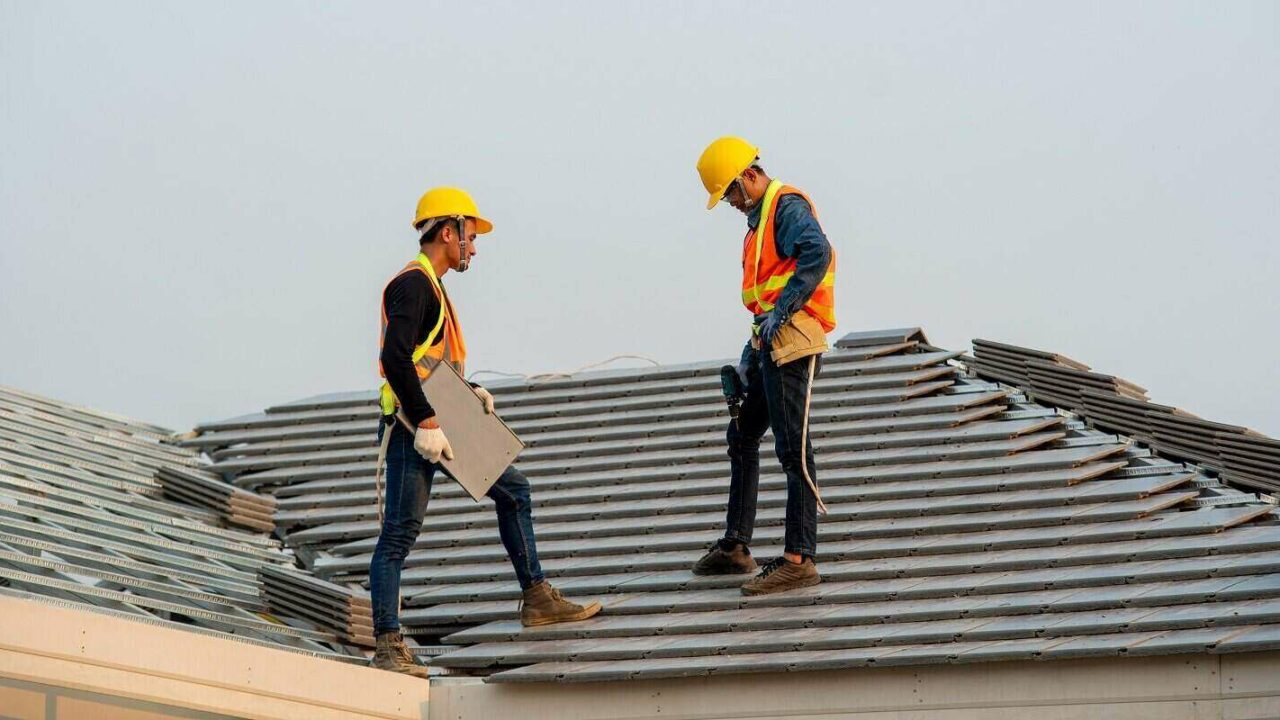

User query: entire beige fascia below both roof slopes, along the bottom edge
[0,589,1280,720]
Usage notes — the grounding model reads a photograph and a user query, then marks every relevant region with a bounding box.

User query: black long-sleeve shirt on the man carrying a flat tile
[380,273,444,425]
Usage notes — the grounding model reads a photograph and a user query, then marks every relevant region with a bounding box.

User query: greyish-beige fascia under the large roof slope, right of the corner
[430,652,1280,720]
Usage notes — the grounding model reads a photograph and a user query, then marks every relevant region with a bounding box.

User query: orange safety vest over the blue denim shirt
[742,181,836,333]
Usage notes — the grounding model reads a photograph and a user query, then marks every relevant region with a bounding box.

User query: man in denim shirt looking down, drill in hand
[692,137,836,594]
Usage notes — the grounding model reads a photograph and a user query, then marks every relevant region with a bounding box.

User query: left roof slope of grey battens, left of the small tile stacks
[0,388,366,660]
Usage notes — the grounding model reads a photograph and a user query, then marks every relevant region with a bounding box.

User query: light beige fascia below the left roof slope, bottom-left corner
[0,597,429,720]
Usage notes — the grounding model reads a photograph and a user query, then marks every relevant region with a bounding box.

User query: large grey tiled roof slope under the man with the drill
[188,329,1280,682]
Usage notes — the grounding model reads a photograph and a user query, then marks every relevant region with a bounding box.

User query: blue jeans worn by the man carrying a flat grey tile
[369,423,545,634]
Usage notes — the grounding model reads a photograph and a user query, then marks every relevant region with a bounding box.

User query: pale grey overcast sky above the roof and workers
[0,0,1280,436]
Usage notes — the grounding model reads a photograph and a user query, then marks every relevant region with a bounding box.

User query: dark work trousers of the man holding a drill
[724,340,822,557]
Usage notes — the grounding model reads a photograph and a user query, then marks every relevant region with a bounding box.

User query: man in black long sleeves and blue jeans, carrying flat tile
[369,187,600,676]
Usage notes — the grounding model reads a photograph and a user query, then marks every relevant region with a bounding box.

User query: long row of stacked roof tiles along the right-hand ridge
[972,340,1280,491]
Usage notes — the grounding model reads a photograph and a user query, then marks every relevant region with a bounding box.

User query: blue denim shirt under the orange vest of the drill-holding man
[746,195,831,322]
